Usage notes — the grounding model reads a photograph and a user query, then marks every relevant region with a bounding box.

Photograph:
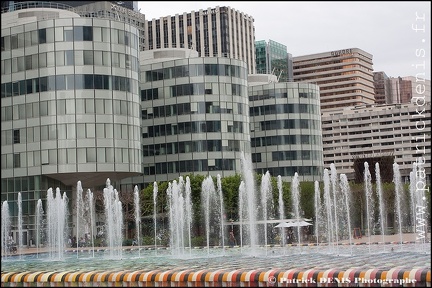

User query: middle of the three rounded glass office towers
[117,48,250,191]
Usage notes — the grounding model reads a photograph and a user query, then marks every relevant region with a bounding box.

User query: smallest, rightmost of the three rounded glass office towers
[248,74,324,181]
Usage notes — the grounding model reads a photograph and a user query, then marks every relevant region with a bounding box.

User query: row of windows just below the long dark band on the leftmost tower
[1,98,140,121]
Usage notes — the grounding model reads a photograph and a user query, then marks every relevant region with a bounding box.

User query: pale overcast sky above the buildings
[138,1,431,80]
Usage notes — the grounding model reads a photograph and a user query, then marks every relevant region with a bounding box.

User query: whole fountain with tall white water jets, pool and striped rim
[1,161,431,287]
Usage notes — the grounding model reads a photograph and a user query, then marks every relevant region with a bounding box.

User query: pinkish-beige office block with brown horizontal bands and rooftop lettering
[293,48,375,111]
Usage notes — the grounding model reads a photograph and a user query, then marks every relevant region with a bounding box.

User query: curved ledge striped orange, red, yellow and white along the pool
[1,267,431,287]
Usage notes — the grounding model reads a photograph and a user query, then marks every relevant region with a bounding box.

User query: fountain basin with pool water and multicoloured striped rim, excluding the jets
[1,243,431,287]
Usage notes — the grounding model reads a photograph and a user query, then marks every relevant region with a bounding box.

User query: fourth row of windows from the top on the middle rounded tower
[143,121,244,138]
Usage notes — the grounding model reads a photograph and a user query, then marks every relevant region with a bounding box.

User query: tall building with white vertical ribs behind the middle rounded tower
[145,6,256,74]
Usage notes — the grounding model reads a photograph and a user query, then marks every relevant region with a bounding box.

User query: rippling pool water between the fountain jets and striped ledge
[1,243,431,274]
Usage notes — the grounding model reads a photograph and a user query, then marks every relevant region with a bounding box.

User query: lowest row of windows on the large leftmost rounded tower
[1,147,141,169]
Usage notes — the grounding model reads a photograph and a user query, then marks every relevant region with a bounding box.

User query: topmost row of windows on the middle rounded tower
[143,64,247,82]
